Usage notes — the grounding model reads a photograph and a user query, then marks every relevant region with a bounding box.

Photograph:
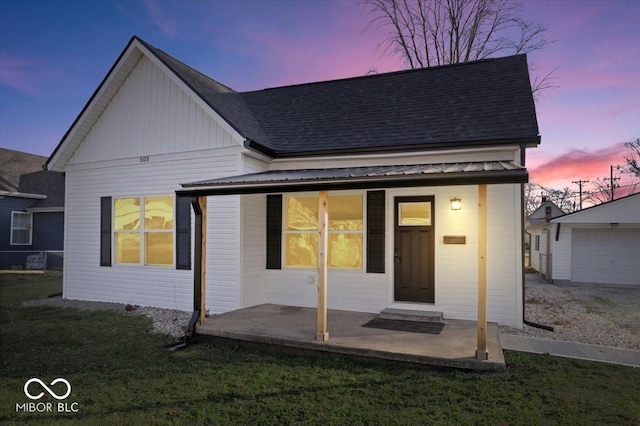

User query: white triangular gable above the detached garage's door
[551,193,640,224]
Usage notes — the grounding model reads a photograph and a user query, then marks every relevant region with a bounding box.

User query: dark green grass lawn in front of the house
[0,274,640,425]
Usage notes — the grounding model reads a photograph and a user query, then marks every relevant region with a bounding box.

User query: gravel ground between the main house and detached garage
[500,276,640,350]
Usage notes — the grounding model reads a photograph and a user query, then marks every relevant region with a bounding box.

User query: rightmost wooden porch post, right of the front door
[476,184,489,360]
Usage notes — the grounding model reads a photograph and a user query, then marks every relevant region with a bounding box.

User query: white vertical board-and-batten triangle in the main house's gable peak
[69,56,238,164]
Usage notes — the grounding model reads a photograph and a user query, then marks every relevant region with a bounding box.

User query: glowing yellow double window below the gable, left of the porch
[113,195,174,266]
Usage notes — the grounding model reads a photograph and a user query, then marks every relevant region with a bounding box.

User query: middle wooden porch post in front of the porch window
[316,191,329,342]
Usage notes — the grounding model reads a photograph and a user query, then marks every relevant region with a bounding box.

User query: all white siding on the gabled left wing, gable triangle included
[64,50,248,314]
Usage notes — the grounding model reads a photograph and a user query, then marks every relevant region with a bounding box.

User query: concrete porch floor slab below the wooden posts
[196,304,505,370]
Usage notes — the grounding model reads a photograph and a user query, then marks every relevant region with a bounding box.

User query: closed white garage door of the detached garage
[571,228,640,285]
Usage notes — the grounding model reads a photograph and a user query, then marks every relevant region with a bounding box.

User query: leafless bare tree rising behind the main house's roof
[362,0,557,93]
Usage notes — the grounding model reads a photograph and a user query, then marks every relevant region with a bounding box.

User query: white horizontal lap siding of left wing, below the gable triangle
[64,148,240,313]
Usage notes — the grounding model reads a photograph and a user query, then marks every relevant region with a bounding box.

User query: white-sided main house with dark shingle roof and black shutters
[47,37,540,327]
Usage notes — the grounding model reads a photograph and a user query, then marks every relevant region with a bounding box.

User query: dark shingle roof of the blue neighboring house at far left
[0,148,64,207]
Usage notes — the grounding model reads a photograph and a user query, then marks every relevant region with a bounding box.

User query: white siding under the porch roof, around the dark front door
[267,185,522,327]
